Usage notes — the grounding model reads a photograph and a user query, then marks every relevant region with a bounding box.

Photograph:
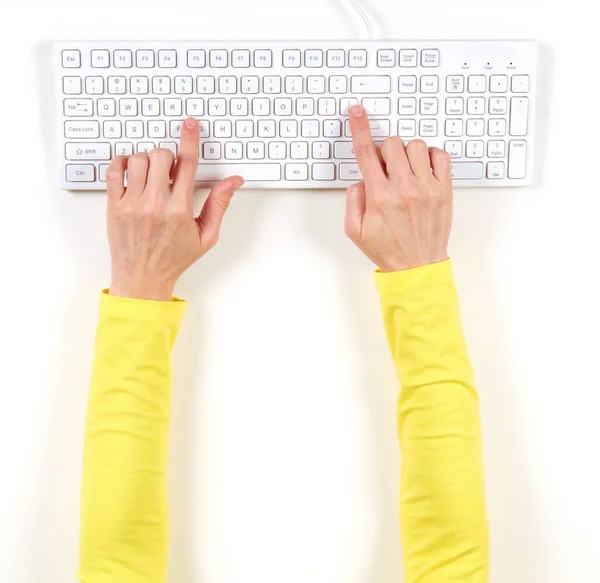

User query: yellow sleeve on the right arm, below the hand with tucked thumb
[375,260,489,583]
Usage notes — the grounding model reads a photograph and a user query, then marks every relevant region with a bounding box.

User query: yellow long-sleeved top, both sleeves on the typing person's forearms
[78,260,489,583]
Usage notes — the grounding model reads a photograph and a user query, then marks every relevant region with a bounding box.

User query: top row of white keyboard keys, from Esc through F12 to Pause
[62,49,440,69]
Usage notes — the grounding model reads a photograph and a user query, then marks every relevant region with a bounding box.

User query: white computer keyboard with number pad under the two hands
[54,41,537,190]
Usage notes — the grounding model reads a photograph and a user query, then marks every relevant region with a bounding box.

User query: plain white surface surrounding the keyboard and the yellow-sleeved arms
[0,0,600,583]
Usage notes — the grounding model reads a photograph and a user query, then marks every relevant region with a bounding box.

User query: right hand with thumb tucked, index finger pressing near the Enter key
[345,106,452,272]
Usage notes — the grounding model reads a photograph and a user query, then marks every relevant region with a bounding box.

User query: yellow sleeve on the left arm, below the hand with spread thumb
[77,293,185,583]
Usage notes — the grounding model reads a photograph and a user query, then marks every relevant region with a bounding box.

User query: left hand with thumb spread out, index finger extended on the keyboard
[106,118,244,301]
